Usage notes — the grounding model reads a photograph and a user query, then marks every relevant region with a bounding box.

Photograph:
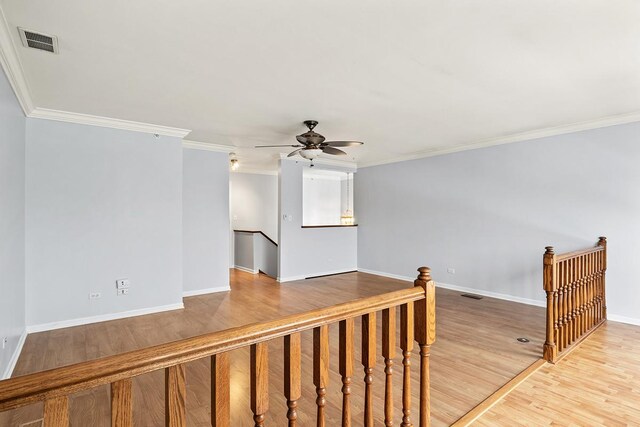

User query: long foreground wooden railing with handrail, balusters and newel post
[0,267,435,427]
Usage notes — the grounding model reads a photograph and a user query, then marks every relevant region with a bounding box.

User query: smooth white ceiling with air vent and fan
[0,0,640,169]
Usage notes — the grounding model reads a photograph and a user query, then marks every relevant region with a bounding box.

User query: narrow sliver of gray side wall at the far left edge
[0,67,25,378]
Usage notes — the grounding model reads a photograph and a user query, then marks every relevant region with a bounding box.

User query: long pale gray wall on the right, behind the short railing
[355,123,640,322]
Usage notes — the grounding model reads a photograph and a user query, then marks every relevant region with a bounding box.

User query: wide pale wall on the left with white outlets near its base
[26,119,182,330]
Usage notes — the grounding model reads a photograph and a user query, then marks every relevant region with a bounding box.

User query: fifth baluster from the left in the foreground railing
[251,342,269,427]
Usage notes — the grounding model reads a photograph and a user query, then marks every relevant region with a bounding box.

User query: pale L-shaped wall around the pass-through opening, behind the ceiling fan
[278,159,358,281]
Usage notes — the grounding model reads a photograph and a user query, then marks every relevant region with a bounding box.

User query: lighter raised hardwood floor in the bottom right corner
[474,322,640,426]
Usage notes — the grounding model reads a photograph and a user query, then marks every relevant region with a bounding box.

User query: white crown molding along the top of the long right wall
[358,111,640,168]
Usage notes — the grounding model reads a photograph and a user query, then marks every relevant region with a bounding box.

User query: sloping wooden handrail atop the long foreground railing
[0,286,424,412]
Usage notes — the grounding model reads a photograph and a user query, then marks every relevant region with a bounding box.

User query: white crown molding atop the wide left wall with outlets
[28,108,191,138]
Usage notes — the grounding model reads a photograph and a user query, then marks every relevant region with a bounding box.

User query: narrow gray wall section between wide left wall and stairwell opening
[182,149,229,295]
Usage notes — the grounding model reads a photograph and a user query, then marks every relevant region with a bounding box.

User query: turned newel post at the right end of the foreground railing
[413,267,436,427]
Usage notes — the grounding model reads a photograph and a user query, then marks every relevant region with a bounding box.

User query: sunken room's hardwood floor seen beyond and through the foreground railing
[0,270,544,426]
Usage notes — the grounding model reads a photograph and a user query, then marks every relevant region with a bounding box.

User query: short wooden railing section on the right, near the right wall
[543,237,607,363]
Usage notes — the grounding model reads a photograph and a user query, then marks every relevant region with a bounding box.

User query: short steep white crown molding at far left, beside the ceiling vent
[0,8,33,116]
